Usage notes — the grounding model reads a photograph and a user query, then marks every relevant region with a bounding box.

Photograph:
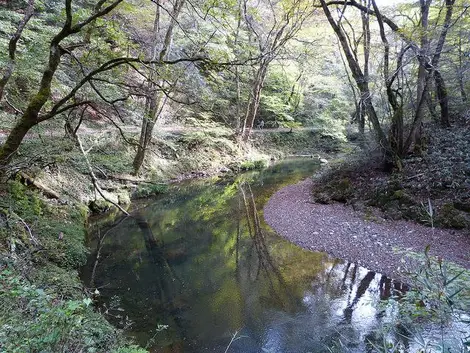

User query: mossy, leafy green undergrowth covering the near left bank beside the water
[0,180,145,353]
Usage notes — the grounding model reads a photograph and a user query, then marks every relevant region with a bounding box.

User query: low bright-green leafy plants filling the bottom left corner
[0,264,140,353]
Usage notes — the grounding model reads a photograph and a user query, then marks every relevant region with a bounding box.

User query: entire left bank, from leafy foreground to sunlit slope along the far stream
[0,123,342,353]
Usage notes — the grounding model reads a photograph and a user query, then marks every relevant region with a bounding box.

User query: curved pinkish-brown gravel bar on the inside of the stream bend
[264,179,470,278]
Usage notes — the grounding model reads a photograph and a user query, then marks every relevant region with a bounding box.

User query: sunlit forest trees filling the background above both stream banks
[0,0,470,174]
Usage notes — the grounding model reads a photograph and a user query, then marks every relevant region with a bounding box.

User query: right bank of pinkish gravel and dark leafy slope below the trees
[265,115,470,277]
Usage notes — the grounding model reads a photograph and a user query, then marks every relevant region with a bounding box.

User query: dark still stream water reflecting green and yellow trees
[82,159,398,353]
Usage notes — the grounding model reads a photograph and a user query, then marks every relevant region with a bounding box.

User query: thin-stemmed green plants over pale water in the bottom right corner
[371,247,470,353]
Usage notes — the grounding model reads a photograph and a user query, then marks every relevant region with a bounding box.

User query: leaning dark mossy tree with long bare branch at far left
[0,0,206,174]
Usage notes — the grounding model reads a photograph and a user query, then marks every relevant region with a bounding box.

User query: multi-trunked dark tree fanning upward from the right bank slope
[320,0,454,167]
